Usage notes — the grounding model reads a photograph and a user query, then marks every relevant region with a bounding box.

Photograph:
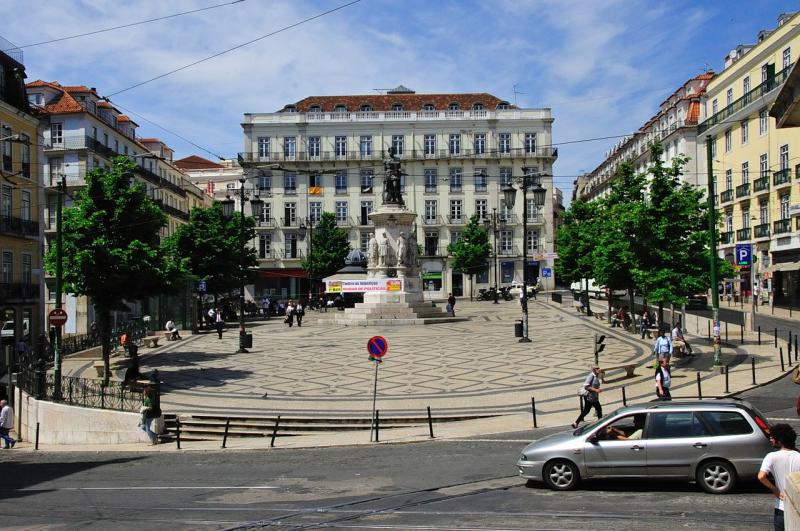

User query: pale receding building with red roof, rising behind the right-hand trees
[573,72,714,201]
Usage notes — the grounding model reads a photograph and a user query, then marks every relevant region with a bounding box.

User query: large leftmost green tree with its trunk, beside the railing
[45,157,176,385]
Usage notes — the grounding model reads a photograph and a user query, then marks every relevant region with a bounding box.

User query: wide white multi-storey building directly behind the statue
[234,86,557,298]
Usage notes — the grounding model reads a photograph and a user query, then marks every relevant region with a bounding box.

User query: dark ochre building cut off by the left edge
[0,38,43,354]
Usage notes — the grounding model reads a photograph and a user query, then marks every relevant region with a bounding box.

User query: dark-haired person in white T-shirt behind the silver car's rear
[758,424,800,531]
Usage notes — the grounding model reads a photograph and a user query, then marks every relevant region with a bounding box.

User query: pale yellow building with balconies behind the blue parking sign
[698,13,800,306]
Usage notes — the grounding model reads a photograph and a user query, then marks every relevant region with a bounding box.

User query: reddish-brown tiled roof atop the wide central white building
[288,92,515,112]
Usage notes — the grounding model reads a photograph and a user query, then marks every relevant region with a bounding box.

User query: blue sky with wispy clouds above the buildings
[0,0,800,198]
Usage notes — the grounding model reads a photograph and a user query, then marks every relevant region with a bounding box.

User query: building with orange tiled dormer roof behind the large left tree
[27,80,205,333]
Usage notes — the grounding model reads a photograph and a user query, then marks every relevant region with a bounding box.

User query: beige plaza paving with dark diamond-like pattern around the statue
[143,301,649,415]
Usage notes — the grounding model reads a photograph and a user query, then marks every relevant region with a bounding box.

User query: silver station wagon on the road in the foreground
[517,399,773,494]
